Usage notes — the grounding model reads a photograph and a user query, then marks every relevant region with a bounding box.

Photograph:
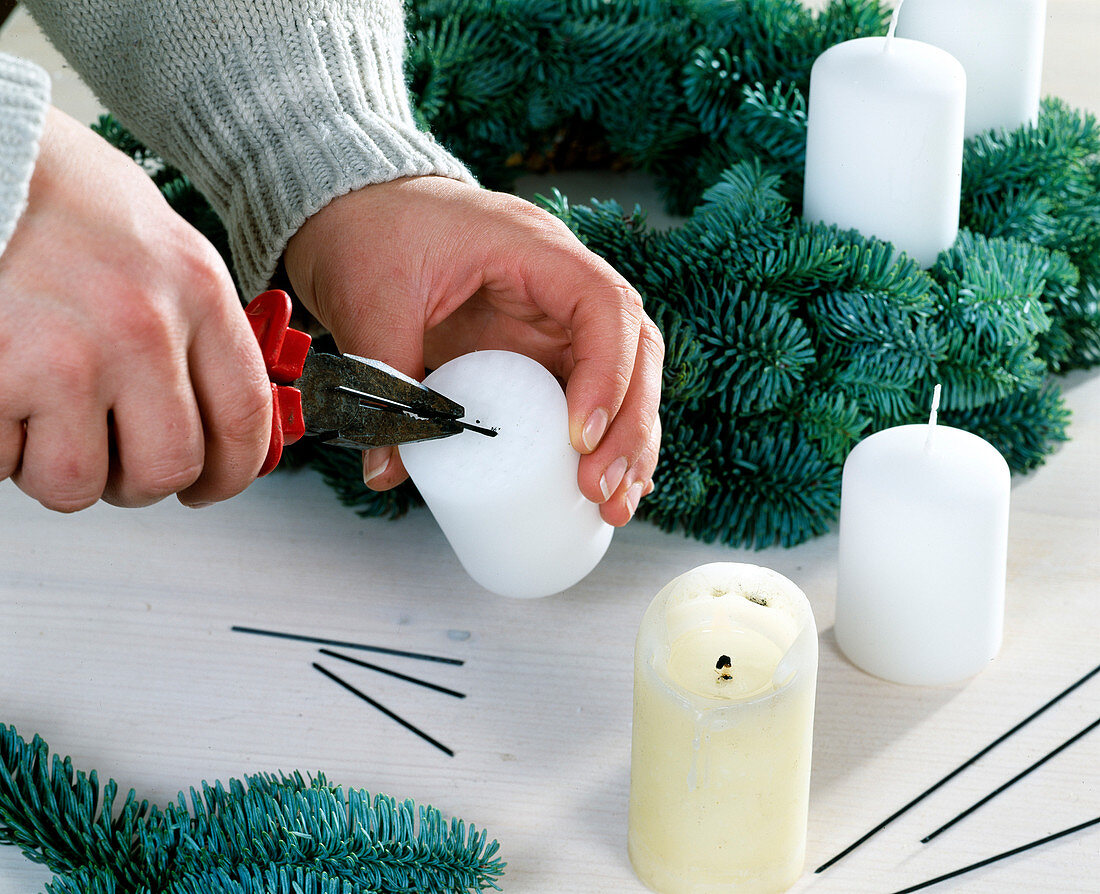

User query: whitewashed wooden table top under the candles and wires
[0,0,1100,894]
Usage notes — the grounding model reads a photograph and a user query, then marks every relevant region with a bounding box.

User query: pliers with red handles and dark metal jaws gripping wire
[244,289,496,475]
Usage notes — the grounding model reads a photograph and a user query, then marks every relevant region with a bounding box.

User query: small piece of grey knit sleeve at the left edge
[0,53,50,254]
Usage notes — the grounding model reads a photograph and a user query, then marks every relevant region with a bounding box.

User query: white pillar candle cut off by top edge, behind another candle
[898,0,1046,136]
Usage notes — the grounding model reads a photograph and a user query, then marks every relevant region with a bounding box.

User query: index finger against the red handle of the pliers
[179,300,272,506]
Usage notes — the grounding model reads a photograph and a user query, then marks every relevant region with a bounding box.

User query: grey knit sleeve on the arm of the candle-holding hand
[24,0,472,297]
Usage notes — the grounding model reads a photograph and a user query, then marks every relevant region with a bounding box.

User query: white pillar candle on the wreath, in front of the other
[803,10,966,267]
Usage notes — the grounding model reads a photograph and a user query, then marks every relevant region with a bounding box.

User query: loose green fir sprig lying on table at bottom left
[0,724,504,894]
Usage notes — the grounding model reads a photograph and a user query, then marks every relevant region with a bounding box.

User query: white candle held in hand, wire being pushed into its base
[400,351,613,597]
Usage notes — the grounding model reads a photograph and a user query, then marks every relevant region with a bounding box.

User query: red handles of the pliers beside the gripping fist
[244,289,312,475]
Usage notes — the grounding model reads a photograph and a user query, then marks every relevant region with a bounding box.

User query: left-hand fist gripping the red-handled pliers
[0,109,272,511]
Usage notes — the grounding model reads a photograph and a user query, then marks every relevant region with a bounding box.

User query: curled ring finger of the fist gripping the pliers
[12,402,109,512]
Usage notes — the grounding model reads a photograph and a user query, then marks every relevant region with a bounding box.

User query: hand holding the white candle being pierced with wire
[284,177,664,526]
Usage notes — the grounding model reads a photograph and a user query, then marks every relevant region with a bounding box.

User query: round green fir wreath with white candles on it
[100,0,1100,548]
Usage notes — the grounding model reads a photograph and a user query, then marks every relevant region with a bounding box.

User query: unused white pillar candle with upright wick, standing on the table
[836,386,1009,685]
